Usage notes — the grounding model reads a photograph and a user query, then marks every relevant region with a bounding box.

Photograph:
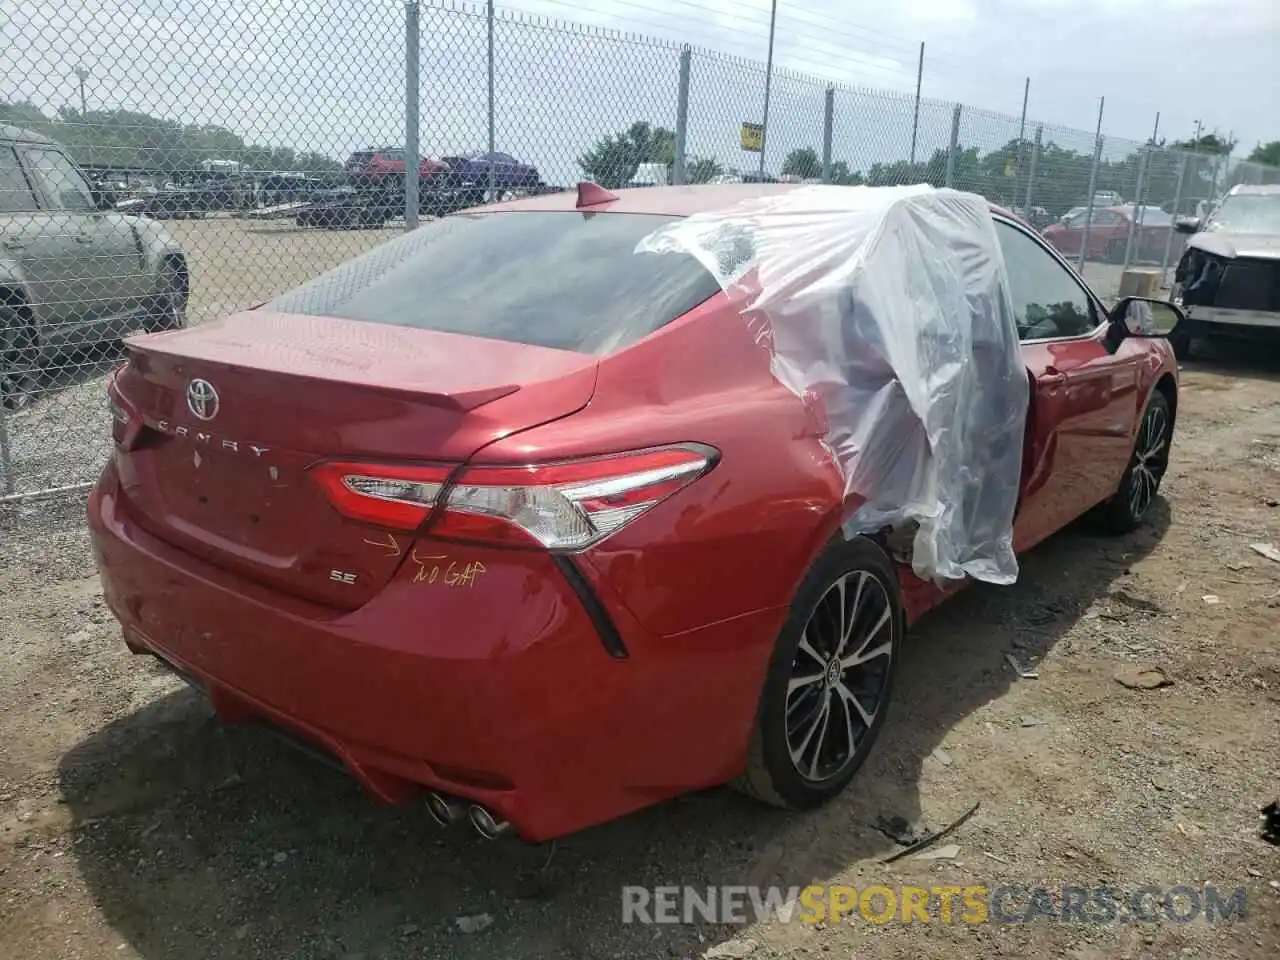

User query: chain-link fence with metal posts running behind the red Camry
[0,0,1280,499]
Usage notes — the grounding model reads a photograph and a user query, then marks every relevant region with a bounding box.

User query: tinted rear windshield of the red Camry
[262,211,719,355]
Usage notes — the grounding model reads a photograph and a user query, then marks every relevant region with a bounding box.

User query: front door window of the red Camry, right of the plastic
[996,220,1098,340]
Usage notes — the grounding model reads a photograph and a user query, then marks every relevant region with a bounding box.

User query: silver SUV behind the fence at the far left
[0,124,189,410]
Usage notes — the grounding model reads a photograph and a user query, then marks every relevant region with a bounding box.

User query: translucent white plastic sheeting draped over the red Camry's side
[636,186,1029,584]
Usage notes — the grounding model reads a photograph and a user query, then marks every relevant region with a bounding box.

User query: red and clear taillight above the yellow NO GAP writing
[305,444,719,550]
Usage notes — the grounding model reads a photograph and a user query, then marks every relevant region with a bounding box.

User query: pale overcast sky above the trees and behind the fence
[0,0,1280,179]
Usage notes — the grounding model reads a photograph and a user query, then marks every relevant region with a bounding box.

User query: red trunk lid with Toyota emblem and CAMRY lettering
[115,311,596,609]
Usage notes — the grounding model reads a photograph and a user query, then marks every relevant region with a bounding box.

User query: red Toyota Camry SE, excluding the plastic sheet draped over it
[88,184,1180,841]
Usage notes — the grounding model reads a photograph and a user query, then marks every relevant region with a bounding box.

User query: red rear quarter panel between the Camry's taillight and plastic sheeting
[465,296,844,635]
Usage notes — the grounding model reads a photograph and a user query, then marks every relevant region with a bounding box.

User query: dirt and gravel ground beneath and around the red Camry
[0,335,1280,960]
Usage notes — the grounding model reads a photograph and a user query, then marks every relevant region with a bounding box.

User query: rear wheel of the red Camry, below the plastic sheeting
[733,536,906,810]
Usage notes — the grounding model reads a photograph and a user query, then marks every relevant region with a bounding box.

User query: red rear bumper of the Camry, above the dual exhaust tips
[88,466,785,841]
